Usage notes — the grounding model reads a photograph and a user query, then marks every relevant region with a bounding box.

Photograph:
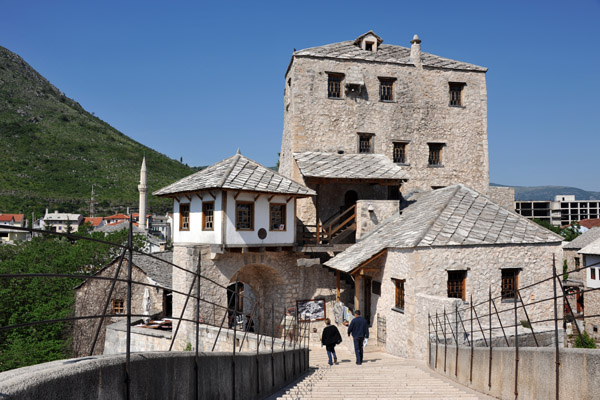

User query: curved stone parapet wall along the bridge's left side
[0,349,309,400]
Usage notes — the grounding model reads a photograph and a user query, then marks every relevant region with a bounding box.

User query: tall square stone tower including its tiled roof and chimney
[279,31,489,228]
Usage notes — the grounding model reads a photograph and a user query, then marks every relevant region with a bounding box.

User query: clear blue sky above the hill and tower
[0,0,600,191]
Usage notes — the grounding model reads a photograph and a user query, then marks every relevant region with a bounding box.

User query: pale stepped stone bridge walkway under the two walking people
[269,345,493,400]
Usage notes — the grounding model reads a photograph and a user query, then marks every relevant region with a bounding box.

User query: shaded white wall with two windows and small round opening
[225,192,296,245]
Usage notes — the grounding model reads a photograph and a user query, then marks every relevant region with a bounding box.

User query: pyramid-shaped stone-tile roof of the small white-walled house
[152,152,316,196]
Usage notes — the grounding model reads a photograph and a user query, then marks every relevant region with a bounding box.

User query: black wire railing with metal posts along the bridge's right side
[428,256,600,399]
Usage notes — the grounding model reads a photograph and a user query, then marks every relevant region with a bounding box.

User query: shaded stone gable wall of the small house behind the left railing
[73,262,163,357]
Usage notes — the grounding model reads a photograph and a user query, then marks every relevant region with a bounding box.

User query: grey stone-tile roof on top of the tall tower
[294,40,487,72]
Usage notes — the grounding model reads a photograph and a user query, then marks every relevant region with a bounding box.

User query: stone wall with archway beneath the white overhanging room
[173,244,347,349]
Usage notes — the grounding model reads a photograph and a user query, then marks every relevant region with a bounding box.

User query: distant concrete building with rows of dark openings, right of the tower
[515,195,600,226]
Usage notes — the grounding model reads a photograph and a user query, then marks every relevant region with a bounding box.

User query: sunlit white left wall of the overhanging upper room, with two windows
[173,190,222,244]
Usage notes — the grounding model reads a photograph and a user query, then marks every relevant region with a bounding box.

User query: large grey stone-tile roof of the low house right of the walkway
[325,185,562,272]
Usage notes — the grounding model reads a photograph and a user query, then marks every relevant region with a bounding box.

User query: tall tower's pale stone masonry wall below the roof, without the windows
[279,50,489,225]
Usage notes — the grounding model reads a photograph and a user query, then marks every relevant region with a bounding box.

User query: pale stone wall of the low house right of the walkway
[370,245,562,358]
